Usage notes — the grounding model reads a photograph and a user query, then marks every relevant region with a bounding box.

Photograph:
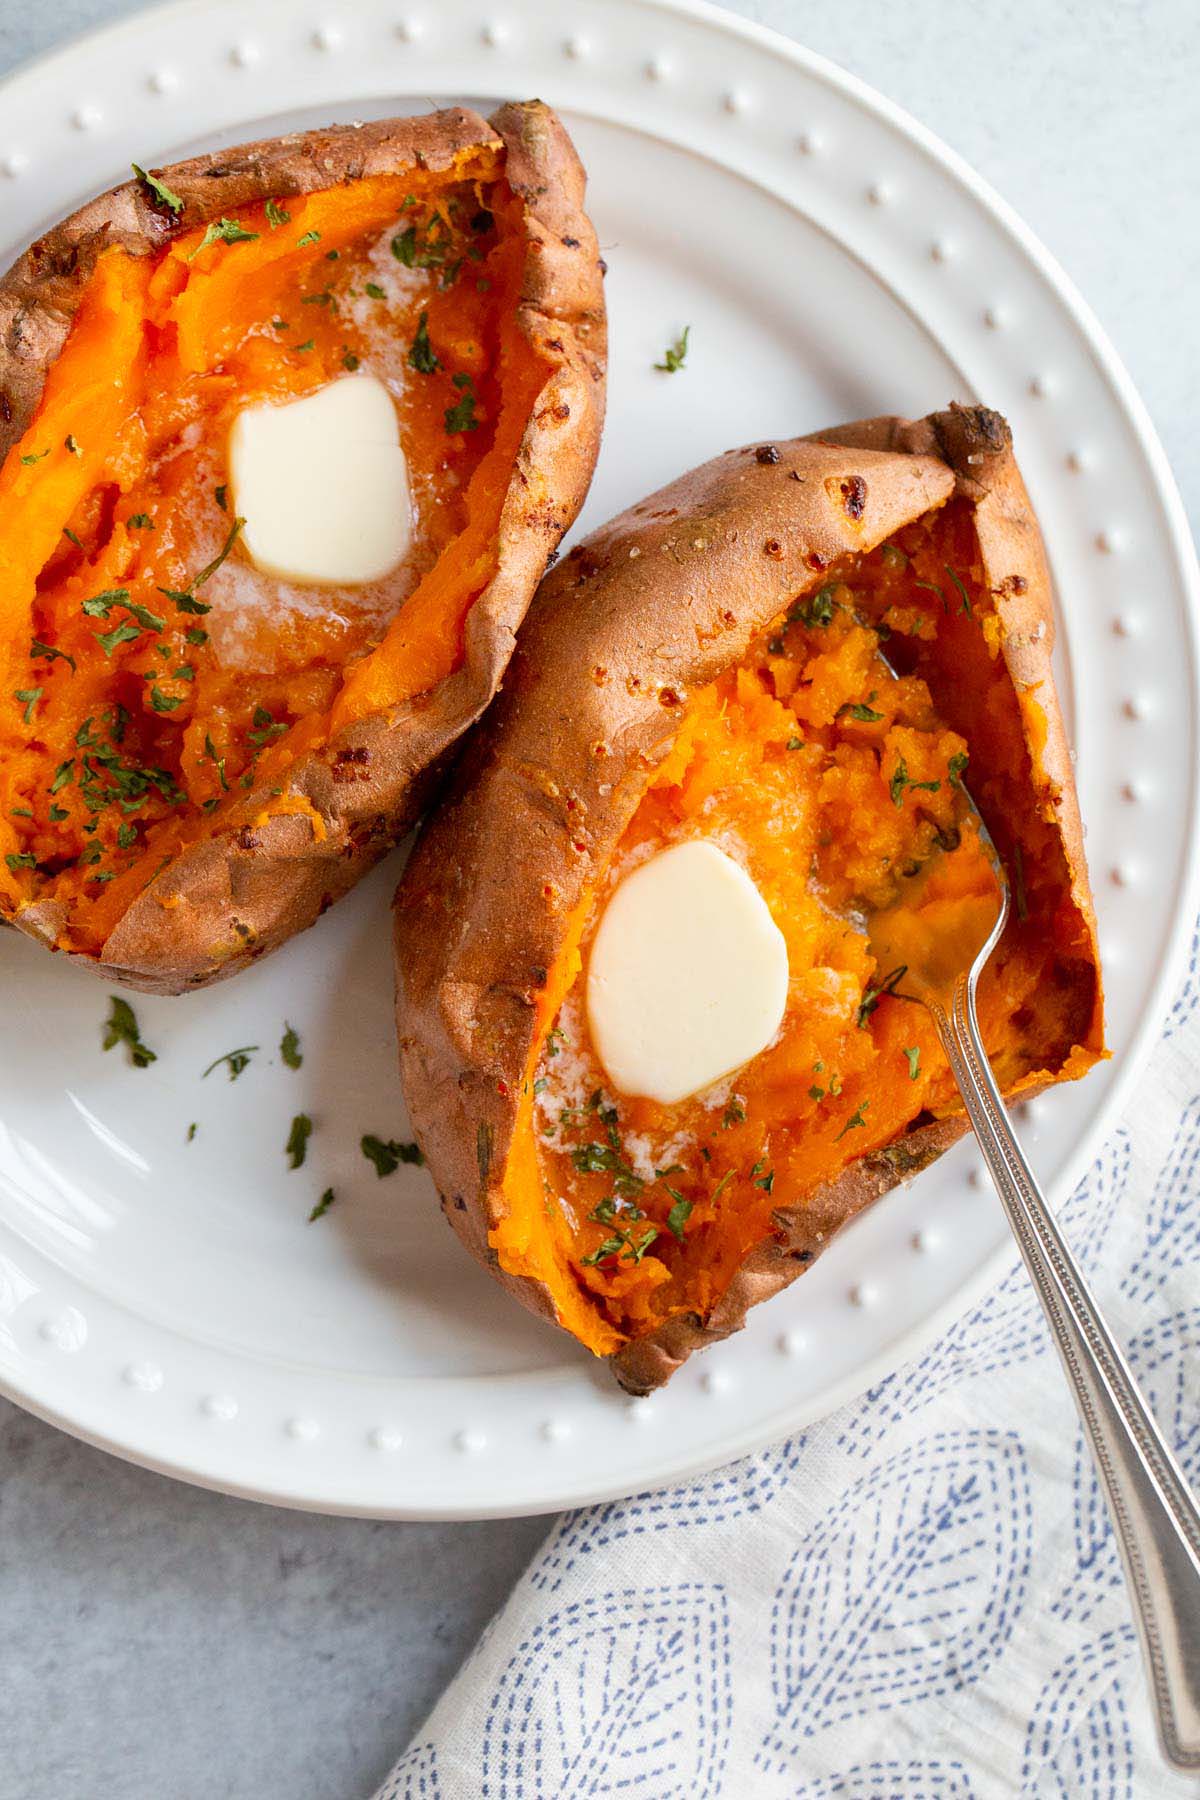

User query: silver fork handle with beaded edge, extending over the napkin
[927,976,1200,1771]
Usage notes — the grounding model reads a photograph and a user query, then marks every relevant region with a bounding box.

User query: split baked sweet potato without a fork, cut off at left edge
[0,103,604,992]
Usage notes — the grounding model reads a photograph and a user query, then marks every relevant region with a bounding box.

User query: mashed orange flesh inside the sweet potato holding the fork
[503,504,1090,1337]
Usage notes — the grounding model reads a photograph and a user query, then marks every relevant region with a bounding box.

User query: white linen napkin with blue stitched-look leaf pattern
[376,934,1200,1800]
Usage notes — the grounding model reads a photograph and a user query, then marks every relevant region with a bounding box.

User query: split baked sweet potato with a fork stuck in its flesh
[396,407,1103,1393]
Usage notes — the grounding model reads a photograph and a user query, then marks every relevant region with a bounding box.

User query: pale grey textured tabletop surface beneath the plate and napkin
[0,0,1200,1800]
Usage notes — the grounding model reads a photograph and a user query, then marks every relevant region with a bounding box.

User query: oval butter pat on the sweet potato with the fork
[587,839,788,1105]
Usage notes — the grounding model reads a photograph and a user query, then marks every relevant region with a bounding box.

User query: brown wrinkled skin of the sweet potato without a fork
[0,101,606,994]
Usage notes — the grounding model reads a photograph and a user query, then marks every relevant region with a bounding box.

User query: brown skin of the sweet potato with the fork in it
[396,407,1099,1393]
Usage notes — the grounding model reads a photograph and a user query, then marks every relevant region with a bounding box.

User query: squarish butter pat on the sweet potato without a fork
[228,374,412,587]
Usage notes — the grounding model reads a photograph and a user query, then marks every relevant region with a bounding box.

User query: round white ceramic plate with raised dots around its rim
[0,0,1200,1517]
